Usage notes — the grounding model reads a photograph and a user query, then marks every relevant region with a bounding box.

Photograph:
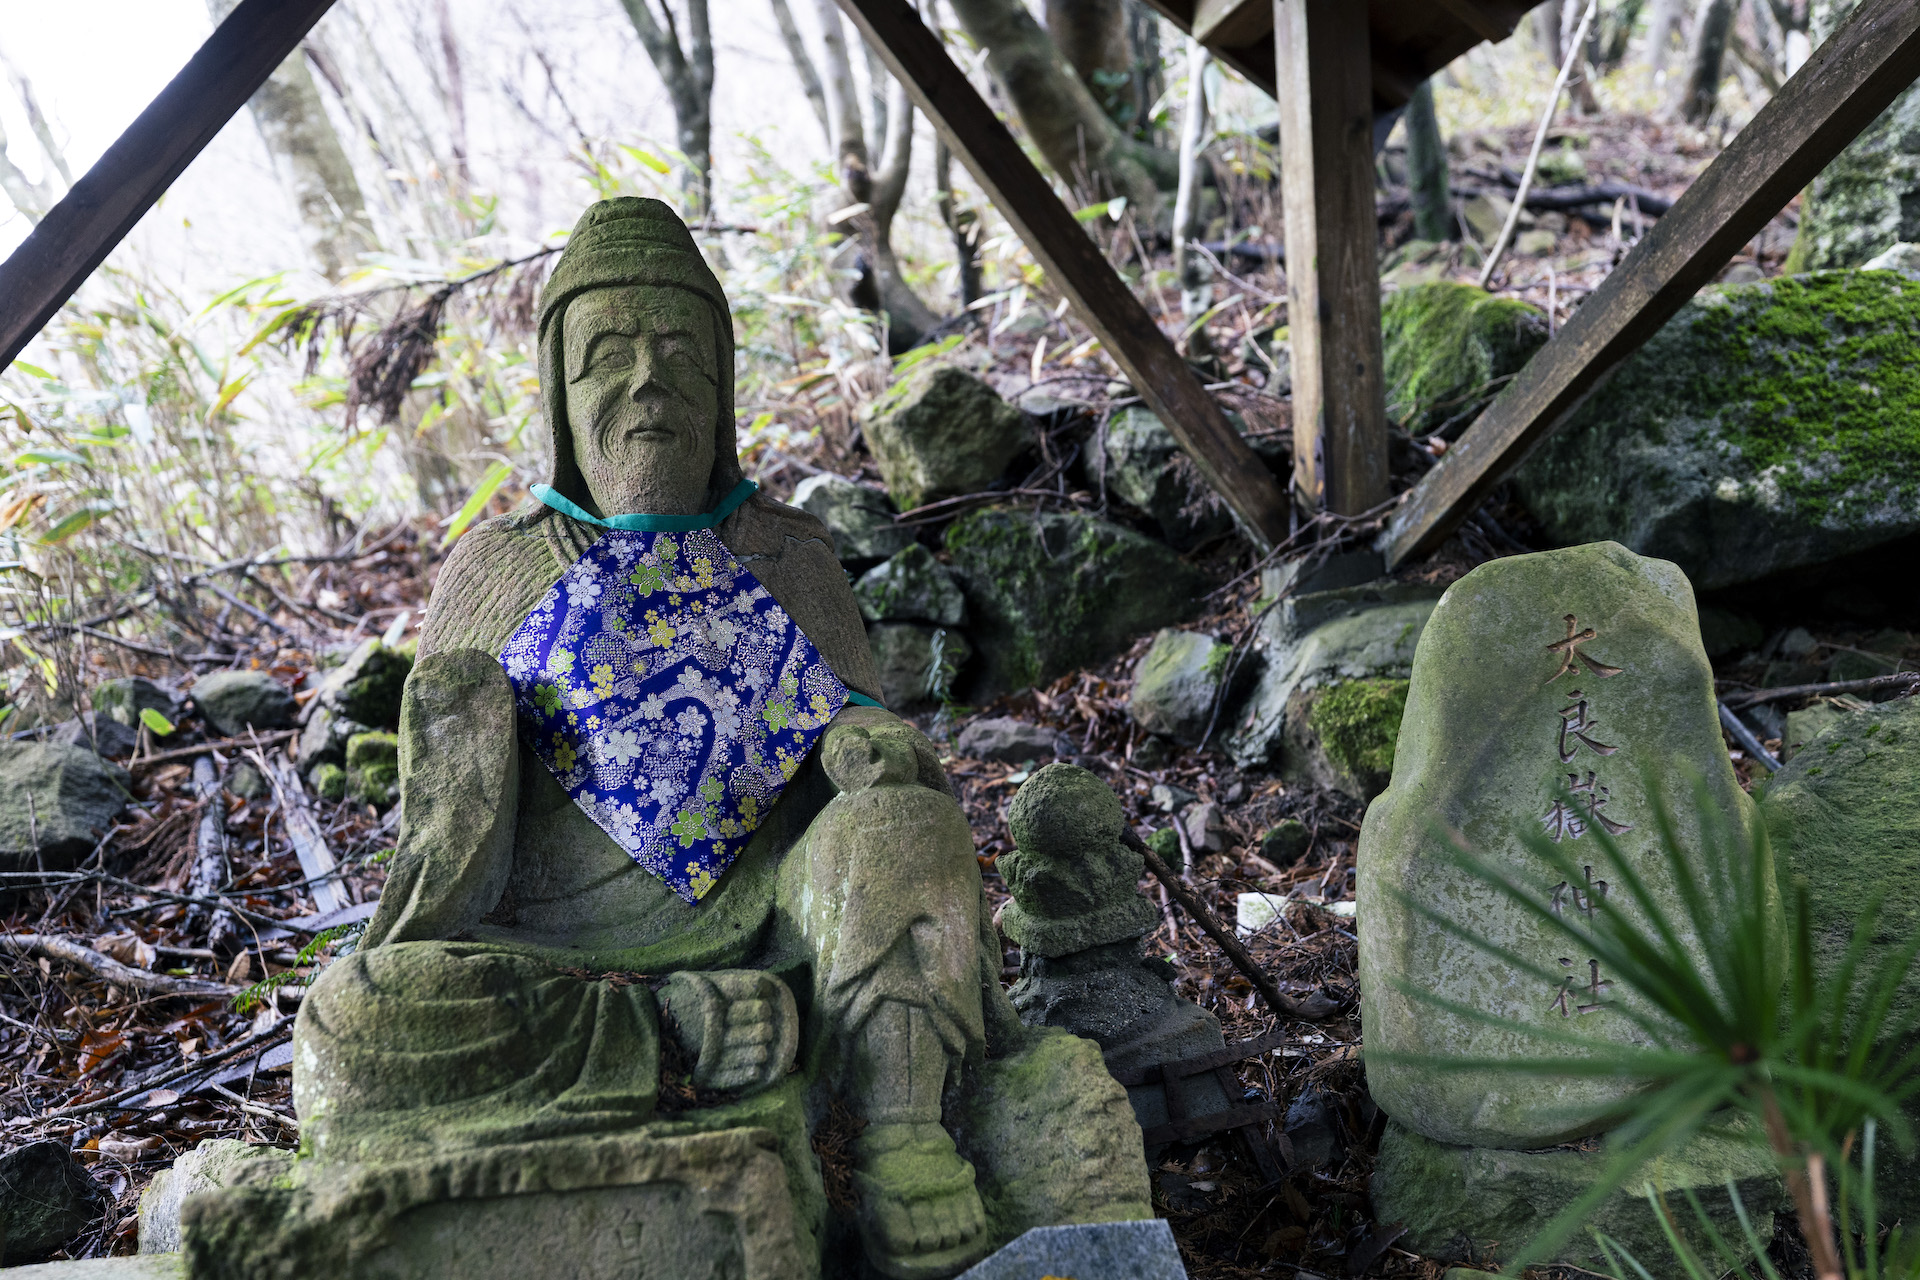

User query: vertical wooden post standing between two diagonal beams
[1273,0,1386,514]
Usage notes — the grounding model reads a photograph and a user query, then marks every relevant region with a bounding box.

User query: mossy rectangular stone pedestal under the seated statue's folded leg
[180,1128,818,1280]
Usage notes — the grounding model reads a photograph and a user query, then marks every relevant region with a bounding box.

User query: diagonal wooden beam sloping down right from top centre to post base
[839,0,1290,551]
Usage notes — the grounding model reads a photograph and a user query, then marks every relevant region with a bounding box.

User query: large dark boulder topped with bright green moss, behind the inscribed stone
[1515,271,1920,589]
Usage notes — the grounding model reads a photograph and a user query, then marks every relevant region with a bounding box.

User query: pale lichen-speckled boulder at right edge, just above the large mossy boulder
[1788,0,1920,271]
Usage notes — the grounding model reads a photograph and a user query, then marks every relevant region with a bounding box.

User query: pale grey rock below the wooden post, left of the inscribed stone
[1223,583,1440,777]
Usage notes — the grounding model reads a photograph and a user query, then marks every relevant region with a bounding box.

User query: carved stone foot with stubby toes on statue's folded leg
[659,969,801,1092]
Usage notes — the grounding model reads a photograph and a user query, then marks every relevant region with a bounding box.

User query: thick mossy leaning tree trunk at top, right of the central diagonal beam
[952,0,1179,214]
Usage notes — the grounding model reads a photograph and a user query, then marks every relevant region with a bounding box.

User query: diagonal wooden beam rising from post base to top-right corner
[1390,0,1920,566]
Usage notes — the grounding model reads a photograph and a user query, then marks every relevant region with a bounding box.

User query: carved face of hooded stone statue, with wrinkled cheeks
[564,286,720,516]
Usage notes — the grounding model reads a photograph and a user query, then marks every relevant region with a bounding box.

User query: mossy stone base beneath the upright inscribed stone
[1371,1121,1788,1276]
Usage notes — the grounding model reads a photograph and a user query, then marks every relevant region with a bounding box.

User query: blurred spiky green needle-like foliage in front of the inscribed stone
[1377,779,1920,1276]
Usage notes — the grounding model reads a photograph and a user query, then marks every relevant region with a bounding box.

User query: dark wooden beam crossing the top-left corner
[0,0,332,368]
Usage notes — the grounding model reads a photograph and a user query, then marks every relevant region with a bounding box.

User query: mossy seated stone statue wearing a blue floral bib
[294,200,1148,1278]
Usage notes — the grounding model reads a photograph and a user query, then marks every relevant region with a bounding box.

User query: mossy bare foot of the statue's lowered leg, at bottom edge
[852,1125,989,1280]
